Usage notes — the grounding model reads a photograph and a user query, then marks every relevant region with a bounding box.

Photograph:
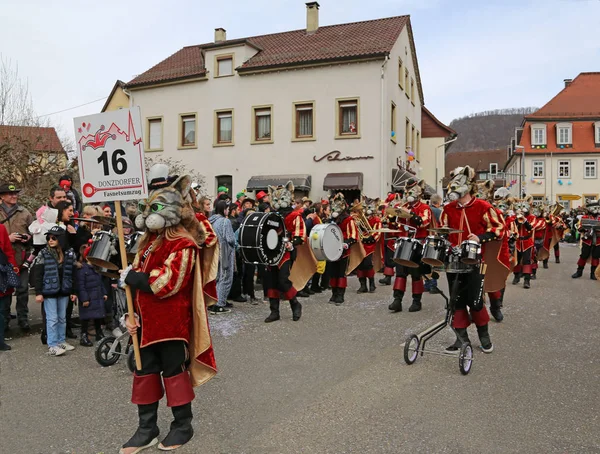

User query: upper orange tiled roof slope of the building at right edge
[525,72,600,120]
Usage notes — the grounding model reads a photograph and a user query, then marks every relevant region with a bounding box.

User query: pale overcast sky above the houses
[0,0,600,145]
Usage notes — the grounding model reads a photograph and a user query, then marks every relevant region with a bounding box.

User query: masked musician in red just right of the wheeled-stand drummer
[511,196,540,289]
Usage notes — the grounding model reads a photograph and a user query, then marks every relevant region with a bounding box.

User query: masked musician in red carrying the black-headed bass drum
[265,181,306,323]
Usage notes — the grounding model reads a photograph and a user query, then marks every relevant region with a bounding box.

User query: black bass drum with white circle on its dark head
[239,213,286,265]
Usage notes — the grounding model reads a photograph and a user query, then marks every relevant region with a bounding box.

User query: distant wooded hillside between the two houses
[448,107,537,153]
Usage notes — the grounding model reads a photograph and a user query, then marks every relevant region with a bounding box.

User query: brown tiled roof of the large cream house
[127,16,423,99]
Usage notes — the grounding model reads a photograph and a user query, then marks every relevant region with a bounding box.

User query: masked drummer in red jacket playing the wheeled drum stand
[441,166,506,353]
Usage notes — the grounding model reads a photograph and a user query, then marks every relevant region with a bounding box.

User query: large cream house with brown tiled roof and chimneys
[113,2,450,200]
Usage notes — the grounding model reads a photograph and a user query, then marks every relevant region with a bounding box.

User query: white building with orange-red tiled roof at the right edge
[505,72,600,209]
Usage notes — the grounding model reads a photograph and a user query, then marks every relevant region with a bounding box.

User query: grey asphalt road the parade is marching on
[0,246,600,454]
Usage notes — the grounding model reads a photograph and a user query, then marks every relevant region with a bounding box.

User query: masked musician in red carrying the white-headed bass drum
[329,192,364,306]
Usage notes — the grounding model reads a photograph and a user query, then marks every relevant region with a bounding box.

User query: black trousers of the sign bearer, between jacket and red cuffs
[136,336,190,377]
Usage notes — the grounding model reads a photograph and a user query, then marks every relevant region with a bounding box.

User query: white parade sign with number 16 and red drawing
[74,108,148,203]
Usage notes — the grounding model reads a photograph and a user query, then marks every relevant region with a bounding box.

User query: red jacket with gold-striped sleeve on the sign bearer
[133,234,198,347]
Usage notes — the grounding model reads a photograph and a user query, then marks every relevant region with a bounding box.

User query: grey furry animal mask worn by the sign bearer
[135,175,191,232]
